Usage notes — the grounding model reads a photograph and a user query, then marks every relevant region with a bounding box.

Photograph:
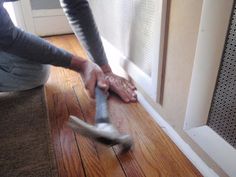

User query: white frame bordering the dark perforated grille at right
[183,0,236,176]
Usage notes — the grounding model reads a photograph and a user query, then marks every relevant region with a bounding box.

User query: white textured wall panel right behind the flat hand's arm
[89,0,162,75]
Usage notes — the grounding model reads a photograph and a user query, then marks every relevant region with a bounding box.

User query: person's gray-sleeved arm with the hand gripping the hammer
[0,3,108,97]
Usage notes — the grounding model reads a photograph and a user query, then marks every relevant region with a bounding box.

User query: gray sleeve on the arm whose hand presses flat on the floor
[60,0,108,66]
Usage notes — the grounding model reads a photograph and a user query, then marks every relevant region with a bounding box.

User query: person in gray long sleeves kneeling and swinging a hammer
[0,0,137,102]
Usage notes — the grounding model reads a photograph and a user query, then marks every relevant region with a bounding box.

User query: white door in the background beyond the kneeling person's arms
[8,0,72,36]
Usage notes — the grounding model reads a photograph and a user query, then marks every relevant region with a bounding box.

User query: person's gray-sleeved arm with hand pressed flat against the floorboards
[60,0,137,102]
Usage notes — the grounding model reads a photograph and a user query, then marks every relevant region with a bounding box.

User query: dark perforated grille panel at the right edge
[207,2,236,148]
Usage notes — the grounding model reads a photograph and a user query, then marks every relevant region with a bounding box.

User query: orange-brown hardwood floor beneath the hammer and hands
[46,35,202,177]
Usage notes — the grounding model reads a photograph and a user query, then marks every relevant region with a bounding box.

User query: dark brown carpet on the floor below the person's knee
[0,87,58,177]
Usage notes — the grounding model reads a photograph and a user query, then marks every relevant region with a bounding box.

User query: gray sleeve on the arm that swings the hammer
[0,3,72,67]
